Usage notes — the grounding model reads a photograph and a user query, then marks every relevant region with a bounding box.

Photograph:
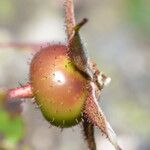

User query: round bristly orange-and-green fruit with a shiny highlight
[30,45,87,127]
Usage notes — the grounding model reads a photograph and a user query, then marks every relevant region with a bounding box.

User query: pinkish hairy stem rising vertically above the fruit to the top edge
[65,0,75,40]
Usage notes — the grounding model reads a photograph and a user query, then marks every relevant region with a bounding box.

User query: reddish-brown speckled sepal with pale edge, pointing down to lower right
[84,82,121,150]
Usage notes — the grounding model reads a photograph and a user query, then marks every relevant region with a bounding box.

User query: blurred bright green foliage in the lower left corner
[0,90,24,149]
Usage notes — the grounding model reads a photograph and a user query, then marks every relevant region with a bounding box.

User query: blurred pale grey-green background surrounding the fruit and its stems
[0,0,150,150]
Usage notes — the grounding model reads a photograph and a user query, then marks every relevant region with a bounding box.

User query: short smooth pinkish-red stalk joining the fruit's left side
[6,84,33,100]
